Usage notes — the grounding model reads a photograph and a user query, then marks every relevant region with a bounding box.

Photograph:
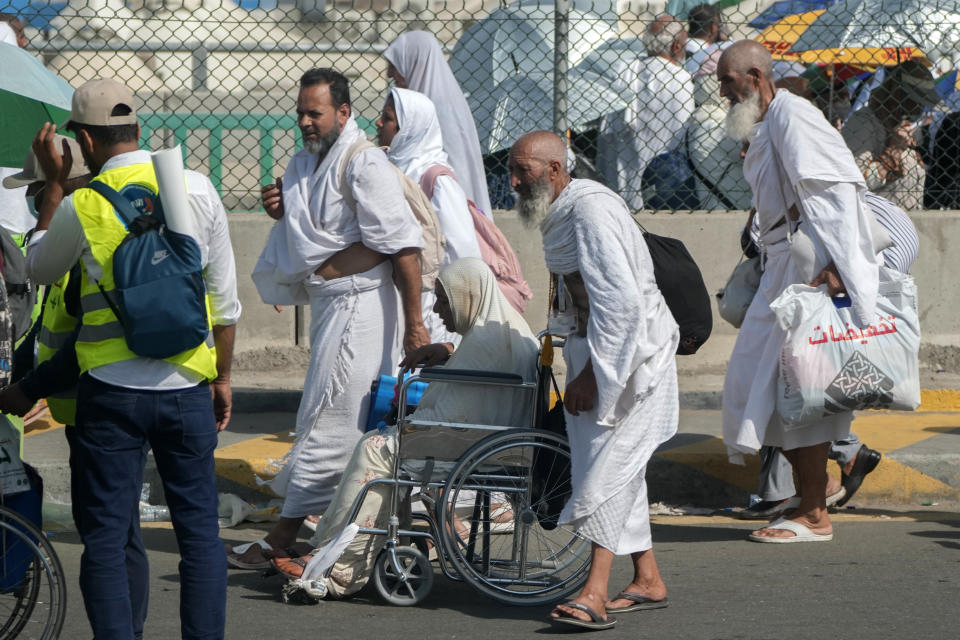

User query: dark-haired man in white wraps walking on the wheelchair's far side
[244,68,430,569]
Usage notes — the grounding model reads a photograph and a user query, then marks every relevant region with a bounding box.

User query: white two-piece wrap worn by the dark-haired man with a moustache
[253,119,423,518]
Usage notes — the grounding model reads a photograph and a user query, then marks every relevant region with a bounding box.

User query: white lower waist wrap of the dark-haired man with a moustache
[268,263,402,518]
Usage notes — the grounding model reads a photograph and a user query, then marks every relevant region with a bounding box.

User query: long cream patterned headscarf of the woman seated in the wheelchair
[415,258,538,426]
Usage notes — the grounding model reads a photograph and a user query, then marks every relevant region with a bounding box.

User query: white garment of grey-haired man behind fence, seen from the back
[597,56,694,211]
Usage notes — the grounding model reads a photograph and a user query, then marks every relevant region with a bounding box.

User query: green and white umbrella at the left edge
[0,42,73,167]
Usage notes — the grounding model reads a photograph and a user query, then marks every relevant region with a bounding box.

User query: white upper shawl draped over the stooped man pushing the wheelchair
[540,180,680,424]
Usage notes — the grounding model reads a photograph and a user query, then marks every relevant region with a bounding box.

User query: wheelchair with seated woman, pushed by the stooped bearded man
[330,344,590,606]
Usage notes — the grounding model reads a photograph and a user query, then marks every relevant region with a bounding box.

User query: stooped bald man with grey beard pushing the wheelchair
[509,131,680,629]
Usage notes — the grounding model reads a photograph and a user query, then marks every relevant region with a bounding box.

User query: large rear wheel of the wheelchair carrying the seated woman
[439,429,590,606]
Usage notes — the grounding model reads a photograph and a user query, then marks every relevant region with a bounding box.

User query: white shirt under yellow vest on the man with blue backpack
[27,151,240,389]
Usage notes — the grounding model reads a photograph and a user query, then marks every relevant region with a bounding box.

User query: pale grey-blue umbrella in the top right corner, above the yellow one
[793,0,960,64]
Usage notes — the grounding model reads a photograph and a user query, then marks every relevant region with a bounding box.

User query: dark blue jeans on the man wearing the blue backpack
[68,375,227,640]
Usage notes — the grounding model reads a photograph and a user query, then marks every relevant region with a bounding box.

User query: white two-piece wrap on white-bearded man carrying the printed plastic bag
[723,90,879,464]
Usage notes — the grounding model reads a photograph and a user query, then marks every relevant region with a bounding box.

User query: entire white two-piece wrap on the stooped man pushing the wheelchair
[540,180,680,554]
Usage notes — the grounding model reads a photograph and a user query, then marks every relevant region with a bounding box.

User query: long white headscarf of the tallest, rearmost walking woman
[383,31,492,216]
